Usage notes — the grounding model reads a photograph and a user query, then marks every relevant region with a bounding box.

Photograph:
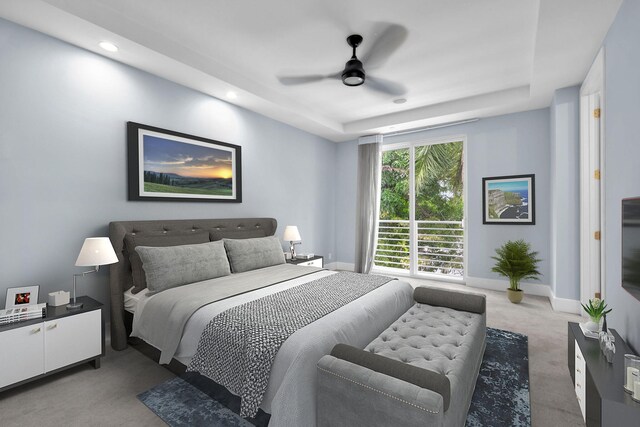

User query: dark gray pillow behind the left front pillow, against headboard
[124,230,209,294]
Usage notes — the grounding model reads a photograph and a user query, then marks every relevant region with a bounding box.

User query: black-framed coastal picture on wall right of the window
[482,175,536,225]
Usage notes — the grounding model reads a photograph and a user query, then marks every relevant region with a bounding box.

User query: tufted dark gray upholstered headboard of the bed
[109,218,278,350]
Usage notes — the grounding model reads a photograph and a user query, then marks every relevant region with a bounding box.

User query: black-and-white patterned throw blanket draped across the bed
[187,272,393,417]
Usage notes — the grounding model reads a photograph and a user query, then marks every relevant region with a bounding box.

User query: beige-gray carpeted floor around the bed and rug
[0,279,584,427]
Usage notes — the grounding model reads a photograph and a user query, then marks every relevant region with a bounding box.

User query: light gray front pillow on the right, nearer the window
[222,236,285,273]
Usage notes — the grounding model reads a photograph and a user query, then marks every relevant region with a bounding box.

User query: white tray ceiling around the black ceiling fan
[0,0,622,141]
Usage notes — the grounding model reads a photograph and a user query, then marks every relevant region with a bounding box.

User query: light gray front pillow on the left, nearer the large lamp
[136,242,231,295]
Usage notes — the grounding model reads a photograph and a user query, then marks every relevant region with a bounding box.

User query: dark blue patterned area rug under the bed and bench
[138,328,531,427]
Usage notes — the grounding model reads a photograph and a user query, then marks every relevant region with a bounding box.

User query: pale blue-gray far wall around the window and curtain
[336,108,551,284]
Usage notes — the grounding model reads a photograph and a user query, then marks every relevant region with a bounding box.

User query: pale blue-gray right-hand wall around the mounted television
[603,0,640,351]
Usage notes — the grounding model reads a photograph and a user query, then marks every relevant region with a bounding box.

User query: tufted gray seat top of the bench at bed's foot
[365,303,484,380]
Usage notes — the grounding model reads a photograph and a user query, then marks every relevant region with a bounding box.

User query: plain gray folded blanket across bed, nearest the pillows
[131,264,321,363]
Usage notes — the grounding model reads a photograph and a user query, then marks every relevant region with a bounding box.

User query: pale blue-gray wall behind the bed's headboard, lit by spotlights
[0,20,337,318]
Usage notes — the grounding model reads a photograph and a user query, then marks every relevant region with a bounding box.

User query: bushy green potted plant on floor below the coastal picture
[491,239,541,304]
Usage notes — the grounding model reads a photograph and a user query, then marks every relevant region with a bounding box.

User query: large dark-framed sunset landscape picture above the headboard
[127,122,242,203]
